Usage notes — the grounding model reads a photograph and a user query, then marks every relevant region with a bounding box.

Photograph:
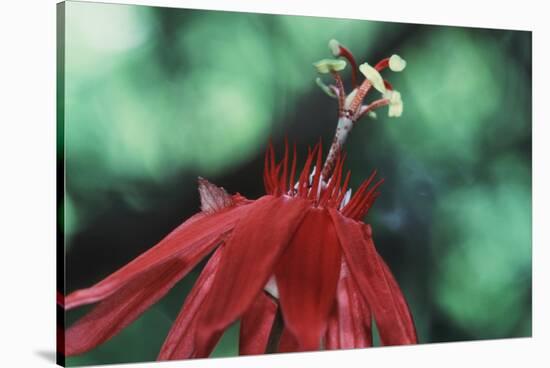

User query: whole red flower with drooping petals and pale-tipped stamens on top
[64,40,417,360]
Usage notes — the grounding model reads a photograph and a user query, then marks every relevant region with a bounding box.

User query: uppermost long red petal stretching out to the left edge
[65,201,251,310]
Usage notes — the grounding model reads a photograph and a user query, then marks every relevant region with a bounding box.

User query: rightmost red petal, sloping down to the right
[329,209,417,345]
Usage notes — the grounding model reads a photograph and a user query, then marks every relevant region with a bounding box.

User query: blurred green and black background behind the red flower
[58,2,531,365]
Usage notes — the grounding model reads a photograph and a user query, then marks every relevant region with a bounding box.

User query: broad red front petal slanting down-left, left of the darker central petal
[197,196,309,356]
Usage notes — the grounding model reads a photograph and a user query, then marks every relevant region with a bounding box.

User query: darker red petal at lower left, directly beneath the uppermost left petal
[65,260,187,356]
